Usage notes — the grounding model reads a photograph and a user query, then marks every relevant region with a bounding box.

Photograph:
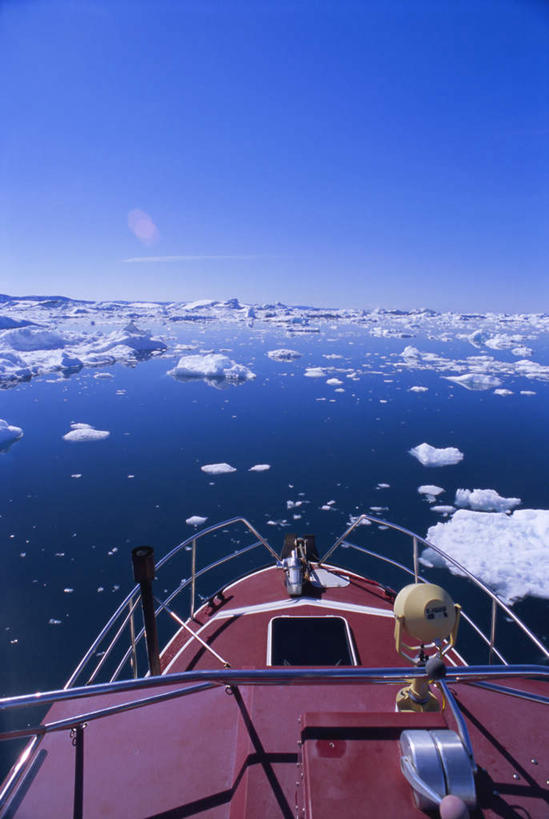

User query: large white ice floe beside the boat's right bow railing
[421,509,549,603]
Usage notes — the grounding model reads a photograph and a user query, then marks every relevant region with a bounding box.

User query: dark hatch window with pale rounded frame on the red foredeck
[269,617,355,665]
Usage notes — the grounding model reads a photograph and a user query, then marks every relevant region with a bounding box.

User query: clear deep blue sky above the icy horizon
[0,0,549,312]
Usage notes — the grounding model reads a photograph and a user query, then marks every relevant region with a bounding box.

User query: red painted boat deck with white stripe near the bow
[5,568,549,819]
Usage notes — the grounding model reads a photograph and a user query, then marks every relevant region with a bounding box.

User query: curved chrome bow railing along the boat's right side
[320,514,549,659]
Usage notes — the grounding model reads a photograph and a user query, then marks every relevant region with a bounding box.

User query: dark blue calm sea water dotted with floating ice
[0,323,549,756]
